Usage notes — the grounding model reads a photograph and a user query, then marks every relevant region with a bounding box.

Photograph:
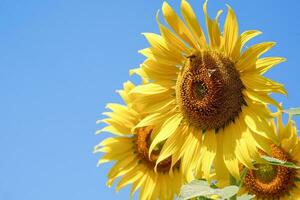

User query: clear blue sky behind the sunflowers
[0,0,300,200]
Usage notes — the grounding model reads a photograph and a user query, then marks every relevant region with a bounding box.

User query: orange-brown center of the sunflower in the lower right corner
[244,145,296,199]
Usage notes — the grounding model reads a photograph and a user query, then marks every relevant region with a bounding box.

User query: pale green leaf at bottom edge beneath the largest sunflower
[179,180,239,200]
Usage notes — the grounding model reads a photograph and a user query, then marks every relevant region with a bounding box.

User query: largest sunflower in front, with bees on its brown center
[130,0,286,179]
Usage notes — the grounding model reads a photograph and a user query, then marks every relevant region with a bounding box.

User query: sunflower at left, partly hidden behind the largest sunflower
[94,82,184,200]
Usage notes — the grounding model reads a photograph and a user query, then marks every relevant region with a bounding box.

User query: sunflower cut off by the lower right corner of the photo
[242,115,300,200]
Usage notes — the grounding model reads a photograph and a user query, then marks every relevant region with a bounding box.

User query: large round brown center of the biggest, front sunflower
[176,51,246,130]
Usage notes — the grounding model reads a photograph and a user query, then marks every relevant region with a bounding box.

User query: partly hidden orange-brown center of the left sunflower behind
[135,127,177,172]
